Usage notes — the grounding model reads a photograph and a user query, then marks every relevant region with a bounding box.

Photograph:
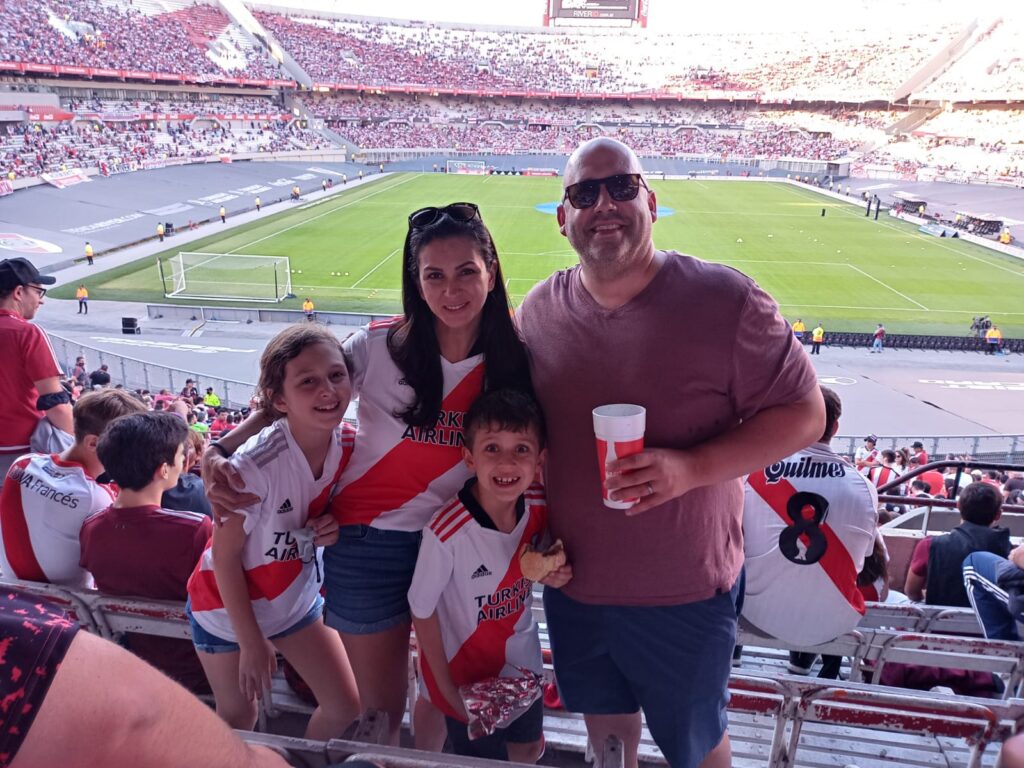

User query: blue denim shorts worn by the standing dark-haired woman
[324,525,423,635]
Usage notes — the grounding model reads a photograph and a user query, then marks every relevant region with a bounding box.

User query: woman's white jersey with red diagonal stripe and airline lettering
[332,318,483,530]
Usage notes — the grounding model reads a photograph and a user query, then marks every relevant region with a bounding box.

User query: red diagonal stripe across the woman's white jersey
[331,362,483,525]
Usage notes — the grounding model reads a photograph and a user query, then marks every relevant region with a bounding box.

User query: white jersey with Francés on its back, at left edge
[0,454,116,588]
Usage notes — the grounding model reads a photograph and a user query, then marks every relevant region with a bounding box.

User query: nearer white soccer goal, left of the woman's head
[157,251,294,302]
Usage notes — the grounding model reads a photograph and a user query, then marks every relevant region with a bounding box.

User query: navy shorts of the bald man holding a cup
[544,574,743,768]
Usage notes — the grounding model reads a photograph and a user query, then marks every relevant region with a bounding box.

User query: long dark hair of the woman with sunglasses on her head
[388,210,532,427]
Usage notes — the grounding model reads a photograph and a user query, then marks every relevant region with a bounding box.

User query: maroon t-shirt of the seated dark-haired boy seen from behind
[79,507,213,691]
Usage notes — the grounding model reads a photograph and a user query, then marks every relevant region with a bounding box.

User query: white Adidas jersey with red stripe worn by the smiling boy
[409,483,548,717]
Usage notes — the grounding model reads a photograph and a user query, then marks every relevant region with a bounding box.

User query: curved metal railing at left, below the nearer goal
[47,332,256,409]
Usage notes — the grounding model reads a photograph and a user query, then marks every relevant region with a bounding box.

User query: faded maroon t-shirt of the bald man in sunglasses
[519,252,817,605]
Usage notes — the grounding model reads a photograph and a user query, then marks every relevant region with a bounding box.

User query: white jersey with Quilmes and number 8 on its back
[743,442,878,645]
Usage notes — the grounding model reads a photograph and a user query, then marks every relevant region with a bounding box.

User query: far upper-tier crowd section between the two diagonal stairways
[257,12,961,101]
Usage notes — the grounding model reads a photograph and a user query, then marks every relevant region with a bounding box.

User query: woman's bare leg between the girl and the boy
[341,622,412,746]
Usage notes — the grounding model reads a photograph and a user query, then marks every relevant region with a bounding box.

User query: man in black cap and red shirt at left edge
[0,257,74,477]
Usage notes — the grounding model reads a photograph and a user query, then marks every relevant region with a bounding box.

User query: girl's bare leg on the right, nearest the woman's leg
[272,621,359,741]
